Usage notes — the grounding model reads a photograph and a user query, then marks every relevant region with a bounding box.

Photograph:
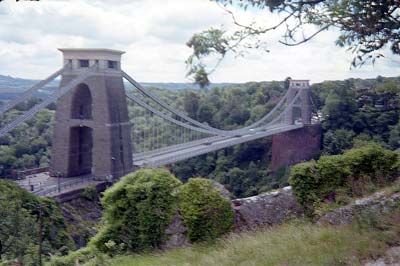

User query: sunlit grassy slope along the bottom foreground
[104,222,398,266]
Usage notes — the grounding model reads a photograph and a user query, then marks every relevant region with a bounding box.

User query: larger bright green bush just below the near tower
[91,169,181,253]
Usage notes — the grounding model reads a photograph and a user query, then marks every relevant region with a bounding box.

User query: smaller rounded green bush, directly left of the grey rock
[179,178,234,241]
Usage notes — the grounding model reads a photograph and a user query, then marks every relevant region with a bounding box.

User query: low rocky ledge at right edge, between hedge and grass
[318,192,400,225]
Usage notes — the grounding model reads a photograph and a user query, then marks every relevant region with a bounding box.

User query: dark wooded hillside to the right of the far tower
[312,77,400,154]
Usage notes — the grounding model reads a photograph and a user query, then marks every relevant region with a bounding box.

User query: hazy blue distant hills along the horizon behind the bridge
[0,75,241,100]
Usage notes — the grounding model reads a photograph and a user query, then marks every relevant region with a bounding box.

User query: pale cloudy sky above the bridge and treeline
[0,0,400,82]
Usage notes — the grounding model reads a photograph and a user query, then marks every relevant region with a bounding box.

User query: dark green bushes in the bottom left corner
[0,180,73,265]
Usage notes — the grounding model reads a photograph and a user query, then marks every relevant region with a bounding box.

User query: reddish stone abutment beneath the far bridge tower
[271,124,322,173]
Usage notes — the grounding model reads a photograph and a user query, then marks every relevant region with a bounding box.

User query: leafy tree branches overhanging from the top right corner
[186,0,400,83]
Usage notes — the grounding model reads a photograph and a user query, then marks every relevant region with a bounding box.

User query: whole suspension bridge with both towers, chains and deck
[0,49,318,196]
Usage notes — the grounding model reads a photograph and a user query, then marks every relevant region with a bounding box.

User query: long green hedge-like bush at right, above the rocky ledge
[290,143,399,216]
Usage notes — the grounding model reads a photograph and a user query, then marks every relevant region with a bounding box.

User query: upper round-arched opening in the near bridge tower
[71,83,92,119]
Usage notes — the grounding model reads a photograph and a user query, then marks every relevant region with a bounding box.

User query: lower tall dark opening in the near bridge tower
[68,126,93,176]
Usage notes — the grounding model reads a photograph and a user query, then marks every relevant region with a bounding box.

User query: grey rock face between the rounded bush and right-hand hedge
[232,187,303,231]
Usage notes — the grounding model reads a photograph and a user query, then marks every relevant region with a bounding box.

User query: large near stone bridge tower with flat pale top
[51,49,132,178]
